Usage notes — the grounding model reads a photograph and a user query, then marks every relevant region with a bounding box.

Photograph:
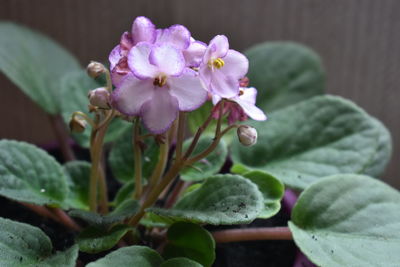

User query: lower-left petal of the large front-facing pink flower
[112,74,154,116]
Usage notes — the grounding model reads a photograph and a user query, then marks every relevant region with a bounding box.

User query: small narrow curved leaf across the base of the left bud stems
[68,199,139,227]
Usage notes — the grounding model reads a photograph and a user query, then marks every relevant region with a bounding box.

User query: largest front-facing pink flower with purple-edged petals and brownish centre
[112,43,207,134]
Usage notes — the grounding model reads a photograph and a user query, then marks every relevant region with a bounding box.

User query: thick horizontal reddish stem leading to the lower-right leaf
[211,227,293,243]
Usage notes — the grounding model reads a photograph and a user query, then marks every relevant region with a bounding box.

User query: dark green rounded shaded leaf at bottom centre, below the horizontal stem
[163,222,215,267]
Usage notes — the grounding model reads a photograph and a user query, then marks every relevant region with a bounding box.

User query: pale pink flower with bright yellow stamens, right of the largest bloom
[199,35,249,98]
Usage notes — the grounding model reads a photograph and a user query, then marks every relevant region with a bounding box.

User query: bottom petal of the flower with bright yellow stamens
[210,69,239,98]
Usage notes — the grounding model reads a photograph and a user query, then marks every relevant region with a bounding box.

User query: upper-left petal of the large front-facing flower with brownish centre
[128,43,158,79]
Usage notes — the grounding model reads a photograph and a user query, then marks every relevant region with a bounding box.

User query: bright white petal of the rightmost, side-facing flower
[233,87,267,121]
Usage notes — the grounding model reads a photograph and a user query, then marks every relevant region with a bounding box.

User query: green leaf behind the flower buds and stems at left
[61,70,131,147]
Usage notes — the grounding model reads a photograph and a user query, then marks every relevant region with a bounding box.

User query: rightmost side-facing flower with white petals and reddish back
[212,87,267,124]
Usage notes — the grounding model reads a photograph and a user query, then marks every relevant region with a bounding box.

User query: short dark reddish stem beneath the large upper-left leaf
[49,115,75,161]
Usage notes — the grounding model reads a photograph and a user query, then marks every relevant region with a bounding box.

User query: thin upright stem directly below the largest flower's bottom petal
[132,117,142,199]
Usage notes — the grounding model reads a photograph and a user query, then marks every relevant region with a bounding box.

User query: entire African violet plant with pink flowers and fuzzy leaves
[0,17,400,267]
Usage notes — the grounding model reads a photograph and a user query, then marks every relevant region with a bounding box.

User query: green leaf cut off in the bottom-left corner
[0,218,78,267]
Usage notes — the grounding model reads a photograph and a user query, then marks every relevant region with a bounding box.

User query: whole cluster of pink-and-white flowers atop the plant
[109,17,266,134]
